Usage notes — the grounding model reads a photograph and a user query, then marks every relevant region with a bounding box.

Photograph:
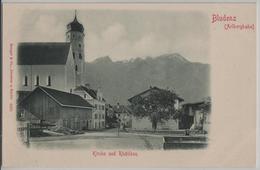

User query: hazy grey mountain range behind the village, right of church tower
[84,53,210,105]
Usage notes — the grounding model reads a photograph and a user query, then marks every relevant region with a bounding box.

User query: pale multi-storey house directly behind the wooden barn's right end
[73,84,106,129]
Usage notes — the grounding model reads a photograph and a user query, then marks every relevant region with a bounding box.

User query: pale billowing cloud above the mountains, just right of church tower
[85,23,174,61]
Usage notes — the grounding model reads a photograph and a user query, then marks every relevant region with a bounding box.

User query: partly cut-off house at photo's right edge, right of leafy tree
[179,98,211,131]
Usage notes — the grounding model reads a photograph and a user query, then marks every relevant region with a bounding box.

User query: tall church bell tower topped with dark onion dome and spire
[66,11,85,87]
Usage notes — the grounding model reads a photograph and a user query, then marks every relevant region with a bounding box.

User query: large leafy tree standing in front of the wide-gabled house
[130,89,180,130]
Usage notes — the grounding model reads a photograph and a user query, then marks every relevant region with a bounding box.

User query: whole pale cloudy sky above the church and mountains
[19,9,210,63]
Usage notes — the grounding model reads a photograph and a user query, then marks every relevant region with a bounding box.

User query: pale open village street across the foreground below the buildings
[30,129,163,149]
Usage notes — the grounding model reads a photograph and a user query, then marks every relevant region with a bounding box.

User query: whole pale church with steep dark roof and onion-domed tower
[17,12,85,92]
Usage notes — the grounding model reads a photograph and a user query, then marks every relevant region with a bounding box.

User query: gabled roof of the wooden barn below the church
[19,86,93,108]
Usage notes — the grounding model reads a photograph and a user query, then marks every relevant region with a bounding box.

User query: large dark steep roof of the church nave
[17,42,70,65]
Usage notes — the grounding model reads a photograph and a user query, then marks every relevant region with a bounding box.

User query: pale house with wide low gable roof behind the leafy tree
[128,87,184,130]
